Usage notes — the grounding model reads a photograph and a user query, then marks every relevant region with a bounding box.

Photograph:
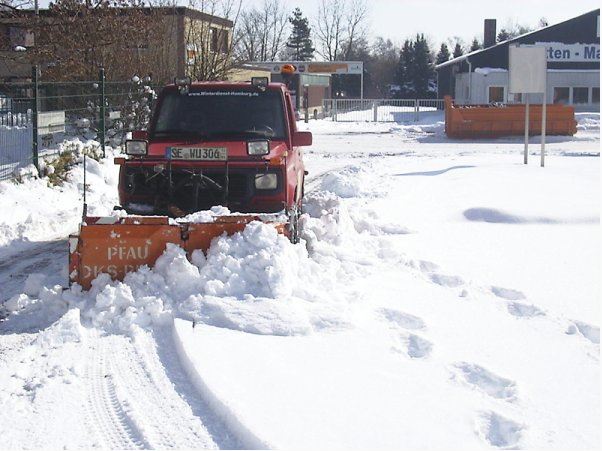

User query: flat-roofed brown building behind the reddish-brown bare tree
[0,7,233,83]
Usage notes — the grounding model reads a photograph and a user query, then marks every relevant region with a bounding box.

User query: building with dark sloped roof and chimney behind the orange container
[436,9,600,111]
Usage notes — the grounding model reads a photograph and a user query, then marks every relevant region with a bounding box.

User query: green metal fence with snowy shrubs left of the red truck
[0,69,152,180]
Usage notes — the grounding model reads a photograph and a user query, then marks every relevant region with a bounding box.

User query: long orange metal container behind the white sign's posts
[445,96,577,138]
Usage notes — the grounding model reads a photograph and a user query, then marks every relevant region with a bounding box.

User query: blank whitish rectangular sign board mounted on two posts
[508,46,548,94]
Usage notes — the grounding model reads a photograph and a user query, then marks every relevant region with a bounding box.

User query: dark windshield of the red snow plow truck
[153,89,286,139]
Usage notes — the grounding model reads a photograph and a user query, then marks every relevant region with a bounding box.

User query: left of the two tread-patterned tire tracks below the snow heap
[86,336,148,449]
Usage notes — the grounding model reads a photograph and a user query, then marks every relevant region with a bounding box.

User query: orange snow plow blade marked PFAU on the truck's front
[69,215,288,290]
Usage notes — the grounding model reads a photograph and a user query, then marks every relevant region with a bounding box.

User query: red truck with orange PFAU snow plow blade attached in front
[69,73,312,289]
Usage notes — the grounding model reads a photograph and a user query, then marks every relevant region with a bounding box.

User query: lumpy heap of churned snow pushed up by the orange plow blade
[5,165,408,335]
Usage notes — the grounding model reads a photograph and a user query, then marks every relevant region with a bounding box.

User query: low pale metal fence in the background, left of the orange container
[322,99,444,122]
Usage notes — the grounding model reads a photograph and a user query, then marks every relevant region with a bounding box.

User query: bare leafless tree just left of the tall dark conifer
[236,0,288,61]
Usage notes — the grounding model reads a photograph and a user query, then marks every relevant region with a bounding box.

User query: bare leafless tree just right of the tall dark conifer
[313,0,368,61]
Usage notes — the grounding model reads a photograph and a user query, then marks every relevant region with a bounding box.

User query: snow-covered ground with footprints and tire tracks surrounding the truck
[0,114,601,449]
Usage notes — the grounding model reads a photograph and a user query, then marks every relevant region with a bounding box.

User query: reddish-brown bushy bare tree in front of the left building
[26,0,155,80]
